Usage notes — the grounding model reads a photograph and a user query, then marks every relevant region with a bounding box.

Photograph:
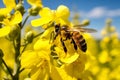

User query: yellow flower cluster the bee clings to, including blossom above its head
[21,5,86,80]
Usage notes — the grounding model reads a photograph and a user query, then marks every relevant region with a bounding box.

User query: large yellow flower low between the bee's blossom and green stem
[21,39,50,80]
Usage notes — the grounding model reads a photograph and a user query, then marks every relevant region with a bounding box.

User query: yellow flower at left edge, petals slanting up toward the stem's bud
[0,11,22,37]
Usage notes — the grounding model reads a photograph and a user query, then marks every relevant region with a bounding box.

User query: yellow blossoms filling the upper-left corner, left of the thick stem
[0,0,22,37]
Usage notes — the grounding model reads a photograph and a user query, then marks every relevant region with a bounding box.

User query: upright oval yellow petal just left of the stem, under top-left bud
[10,11,22,24]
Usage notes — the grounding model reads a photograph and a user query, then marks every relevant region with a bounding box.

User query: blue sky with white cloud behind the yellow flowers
[0,0,120,38]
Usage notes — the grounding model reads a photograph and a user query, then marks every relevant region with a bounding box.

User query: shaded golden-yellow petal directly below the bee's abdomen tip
[65,54,86,78]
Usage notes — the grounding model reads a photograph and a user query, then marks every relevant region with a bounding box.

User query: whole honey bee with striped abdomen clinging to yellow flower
[54,24,96,53]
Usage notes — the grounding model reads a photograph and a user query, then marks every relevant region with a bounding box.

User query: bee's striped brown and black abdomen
[72,31,87,52]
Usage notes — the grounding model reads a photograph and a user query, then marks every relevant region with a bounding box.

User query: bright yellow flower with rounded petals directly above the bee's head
[31,5,70,26]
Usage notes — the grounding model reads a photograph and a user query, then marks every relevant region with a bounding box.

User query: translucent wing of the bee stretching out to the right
[68,27,97,33]
